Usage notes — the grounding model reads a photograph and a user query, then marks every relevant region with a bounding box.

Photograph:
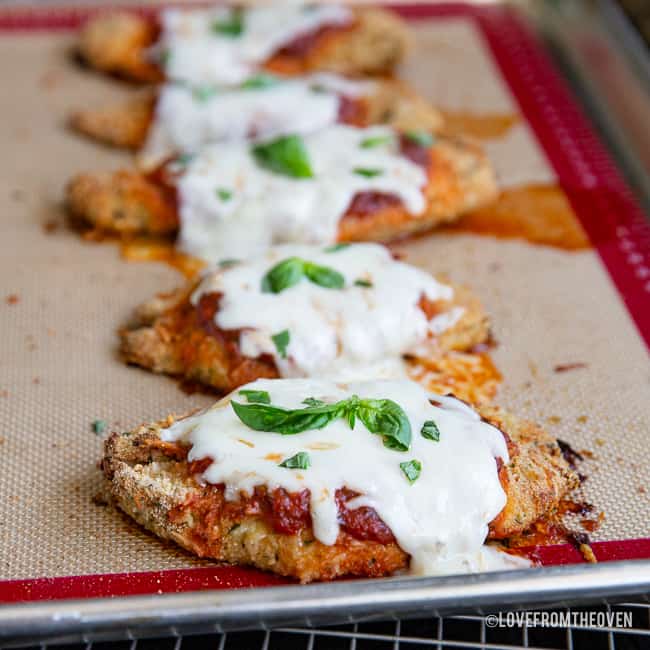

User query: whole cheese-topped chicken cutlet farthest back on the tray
[78,3,410,84]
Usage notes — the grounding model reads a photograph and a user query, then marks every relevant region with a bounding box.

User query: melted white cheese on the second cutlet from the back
[139,73,374,167]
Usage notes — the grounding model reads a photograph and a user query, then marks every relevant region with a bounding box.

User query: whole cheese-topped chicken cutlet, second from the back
[71,72,443,168]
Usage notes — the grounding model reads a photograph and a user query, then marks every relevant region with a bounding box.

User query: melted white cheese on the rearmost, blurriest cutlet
[157,3,353,84]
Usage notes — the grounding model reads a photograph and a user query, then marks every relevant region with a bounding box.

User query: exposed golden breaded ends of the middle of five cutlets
[66,137,497,242]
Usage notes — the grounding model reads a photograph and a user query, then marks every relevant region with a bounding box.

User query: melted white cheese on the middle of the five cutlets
[178,125,426,262]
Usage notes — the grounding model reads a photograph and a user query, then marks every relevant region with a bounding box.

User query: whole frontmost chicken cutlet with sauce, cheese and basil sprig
[102,379,578,582]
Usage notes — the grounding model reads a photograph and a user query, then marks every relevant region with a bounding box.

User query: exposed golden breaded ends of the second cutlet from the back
[69,79,443,150]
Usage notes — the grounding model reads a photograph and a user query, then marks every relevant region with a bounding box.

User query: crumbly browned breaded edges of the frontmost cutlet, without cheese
[102,407,578,582]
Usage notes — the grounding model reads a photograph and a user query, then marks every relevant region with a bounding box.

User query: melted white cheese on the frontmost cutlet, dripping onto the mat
[161,379,516,574]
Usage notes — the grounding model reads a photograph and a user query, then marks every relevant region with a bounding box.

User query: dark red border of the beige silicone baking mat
[0,3,650,603]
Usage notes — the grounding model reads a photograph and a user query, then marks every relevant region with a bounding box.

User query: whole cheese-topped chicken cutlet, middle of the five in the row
[66,124,496,262]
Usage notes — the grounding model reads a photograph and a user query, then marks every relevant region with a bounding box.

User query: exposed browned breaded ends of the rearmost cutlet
[77,8,410,83]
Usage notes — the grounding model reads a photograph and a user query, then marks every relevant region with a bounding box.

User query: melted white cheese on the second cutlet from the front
[192,244,456,380]
